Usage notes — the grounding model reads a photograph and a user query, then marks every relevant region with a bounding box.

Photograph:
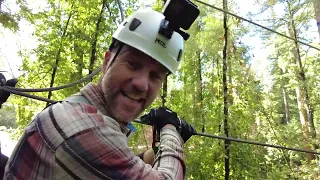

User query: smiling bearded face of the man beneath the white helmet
[100,46,168,123]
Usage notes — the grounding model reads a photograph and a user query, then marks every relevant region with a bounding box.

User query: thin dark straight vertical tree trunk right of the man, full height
[222,0,230,180]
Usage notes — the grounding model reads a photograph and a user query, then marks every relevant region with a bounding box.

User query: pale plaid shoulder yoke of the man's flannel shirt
[35,101,106,151]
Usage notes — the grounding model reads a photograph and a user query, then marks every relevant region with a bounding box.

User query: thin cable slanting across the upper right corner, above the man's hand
[194,0,320,51]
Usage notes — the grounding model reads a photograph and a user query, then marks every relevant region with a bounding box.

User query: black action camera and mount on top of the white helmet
[159,0,200,41]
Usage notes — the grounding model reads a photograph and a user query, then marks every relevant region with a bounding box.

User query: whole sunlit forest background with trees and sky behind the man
[0,0,320,180]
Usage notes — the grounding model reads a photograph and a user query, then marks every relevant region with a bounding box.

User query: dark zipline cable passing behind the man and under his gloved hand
[0,86,320,155]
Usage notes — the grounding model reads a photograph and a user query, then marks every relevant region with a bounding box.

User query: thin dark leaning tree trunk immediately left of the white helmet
[89,0,107,78]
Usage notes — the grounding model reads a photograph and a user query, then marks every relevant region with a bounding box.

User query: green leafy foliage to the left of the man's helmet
[10,0,141,135]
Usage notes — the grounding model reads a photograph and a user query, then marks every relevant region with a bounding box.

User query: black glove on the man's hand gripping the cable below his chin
[141,107,196,142]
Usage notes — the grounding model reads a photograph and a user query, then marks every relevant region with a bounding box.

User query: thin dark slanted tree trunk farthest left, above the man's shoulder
[47,4,74,106]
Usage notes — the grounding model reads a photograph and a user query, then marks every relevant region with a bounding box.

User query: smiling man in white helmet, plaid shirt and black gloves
[4,10,194,180]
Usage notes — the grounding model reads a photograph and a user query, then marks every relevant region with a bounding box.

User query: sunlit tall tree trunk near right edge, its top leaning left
[287,2,316,162]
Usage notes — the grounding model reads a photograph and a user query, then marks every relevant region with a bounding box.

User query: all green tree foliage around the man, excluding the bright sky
[0,0,320,180]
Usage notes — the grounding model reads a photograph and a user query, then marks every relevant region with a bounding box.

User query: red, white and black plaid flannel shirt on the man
[4,84,185,180]
